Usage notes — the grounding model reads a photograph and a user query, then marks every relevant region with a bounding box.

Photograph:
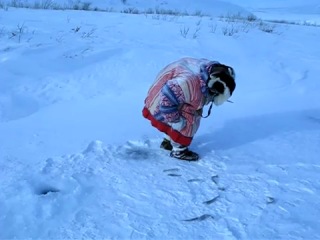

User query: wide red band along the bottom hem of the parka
[142,107,192,146]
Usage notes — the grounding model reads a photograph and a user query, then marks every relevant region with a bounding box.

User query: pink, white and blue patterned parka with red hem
[142,58,218,146]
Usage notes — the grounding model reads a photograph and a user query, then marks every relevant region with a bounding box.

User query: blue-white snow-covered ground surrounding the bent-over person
[0,0,320,239]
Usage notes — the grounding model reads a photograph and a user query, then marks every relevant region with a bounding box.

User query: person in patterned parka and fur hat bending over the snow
[142,58,236,161]
